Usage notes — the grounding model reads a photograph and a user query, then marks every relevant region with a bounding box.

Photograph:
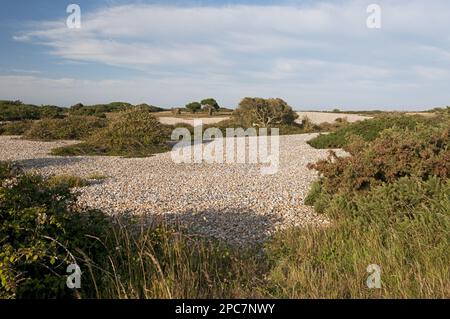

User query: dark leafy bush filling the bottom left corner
[0,163,108,298]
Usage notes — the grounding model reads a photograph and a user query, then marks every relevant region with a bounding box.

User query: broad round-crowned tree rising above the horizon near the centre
[233,97,298,127]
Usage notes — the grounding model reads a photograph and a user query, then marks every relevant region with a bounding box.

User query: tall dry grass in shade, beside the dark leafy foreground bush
[79,219,264,299]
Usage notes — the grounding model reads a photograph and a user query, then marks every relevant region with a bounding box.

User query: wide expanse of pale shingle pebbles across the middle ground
[0,134,343,245]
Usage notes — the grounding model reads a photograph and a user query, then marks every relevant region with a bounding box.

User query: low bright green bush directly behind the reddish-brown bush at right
[308,115,431,149]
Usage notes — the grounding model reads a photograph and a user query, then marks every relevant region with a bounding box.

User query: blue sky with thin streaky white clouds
[0,0,450,111]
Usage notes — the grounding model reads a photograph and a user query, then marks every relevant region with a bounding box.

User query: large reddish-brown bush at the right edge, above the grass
[310,121,450,201]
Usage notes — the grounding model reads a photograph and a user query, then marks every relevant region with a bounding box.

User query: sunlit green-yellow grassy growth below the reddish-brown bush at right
[267,180,450,298]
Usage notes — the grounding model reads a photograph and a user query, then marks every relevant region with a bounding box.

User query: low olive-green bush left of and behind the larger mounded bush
[23,116,106,141]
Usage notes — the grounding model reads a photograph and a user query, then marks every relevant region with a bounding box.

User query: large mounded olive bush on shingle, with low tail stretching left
[53,108,171,156]
